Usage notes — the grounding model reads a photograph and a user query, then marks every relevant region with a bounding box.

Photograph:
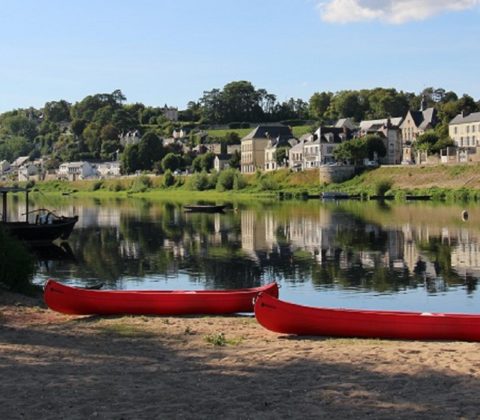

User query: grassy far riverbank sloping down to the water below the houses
[5,164,480,200]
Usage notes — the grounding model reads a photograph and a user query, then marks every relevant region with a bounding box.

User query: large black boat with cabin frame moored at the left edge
[0,187,78,243]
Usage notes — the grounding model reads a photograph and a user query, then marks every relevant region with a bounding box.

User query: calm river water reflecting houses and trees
[8,197,480,313]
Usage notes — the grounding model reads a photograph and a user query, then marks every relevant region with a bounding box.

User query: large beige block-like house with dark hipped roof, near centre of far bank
[241,124,293,174]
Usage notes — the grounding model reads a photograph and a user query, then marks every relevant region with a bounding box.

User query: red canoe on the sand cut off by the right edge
[255,293,480,341]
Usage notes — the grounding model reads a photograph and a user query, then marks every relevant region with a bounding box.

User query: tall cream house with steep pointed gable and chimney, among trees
[400,97,438,163]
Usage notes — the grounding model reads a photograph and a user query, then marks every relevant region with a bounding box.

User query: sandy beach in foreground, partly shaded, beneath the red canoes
[0,292,480,419]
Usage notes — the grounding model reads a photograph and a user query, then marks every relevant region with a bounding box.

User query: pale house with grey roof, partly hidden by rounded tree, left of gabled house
[359,117,403,165]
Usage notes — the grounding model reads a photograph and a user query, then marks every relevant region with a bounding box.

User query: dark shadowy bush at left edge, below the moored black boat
[0,227,36,294]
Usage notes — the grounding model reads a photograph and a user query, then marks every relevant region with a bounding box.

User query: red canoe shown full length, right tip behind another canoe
[43,280,278,315]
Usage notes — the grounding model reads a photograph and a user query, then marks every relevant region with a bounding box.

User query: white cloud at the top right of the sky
[318,0,480,24]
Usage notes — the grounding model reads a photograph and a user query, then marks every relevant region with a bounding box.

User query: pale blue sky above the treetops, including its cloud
[0,0,480,113]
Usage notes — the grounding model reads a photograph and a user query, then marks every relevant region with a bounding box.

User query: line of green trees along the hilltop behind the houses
[0,81,480,172]
